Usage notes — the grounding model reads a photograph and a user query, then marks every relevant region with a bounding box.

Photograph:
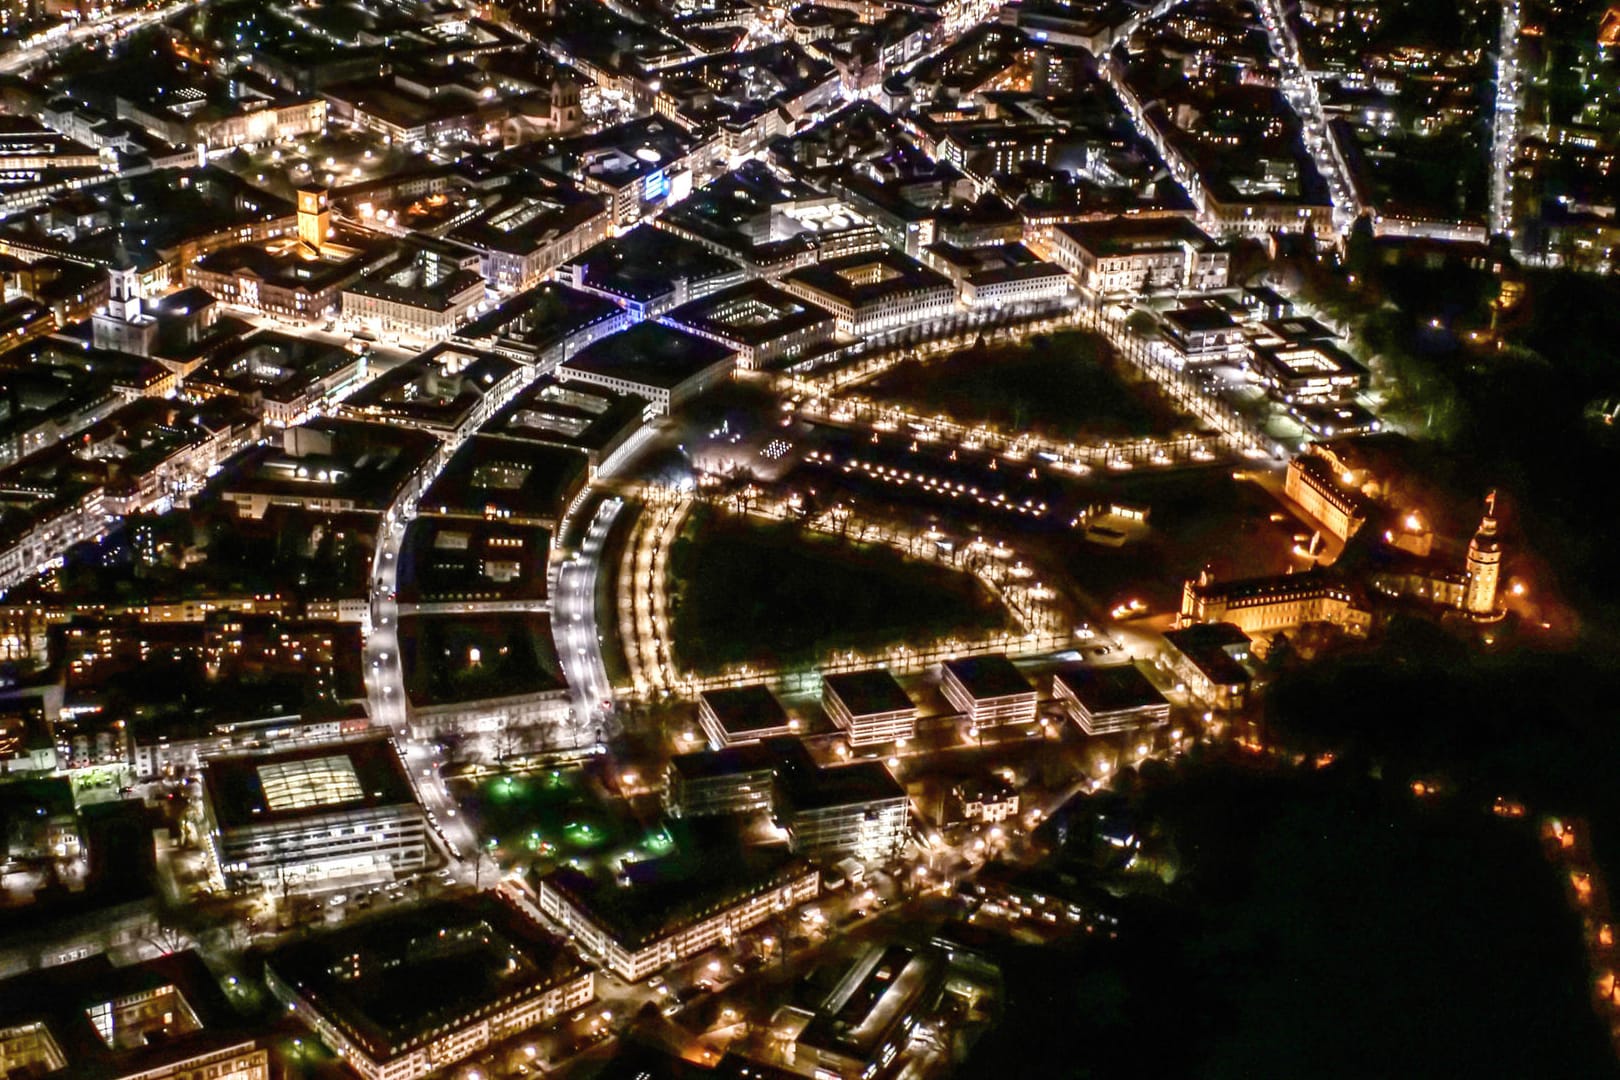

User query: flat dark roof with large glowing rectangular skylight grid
[203,738,416,829]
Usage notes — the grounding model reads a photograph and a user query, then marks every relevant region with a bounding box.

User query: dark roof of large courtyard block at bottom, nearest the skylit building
[266,894,586,1059]
